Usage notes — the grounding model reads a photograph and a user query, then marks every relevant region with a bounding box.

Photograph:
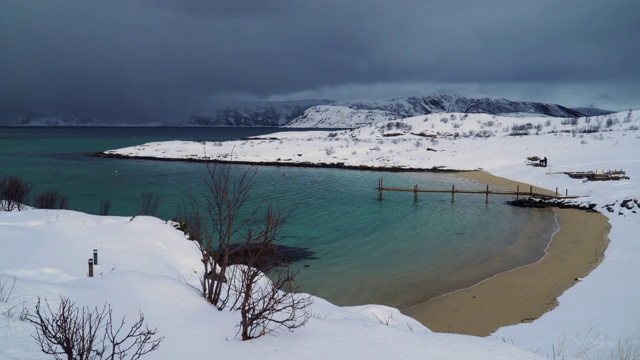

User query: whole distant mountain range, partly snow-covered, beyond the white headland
[179,94,583,128]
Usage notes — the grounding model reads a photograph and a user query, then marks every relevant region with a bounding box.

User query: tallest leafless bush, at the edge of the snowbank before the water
[178,164,311,340]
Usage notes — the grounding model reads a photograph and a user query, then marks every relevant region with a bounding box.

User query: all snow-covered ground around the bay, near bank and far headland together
[0,111,640,359]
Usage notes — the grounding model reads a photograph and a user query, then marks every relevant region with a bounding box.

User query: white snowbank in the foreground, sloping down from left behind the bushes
[0,210,539,360]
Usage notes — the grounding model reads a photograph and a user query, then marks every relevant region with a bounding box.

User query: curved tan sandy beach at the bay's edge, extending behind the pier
[403,171,610,336]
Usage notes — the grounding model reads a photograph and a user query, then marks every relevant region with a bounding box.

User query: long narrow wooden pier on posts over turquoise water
[374,178,578,203]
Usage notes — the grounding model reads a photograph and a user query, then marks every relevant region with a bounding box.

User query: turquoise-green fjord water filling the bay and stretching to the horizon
[0,127,556,308]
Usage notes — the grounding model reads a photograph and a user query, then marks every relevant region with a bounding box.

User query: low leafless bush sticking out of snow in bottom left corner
[27,296,164,360]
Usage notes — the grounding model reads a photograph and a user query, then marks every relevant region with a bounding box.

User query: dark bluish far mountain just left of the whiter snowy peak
[178,100,333,126]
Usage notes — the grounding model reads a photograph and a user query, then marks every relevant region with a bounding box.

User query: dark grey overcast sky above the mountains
[0,0,640,123]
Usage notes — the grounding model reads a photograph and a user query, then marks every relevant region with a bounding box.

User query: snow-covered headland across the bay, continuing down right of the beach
[96,110,640,358]
